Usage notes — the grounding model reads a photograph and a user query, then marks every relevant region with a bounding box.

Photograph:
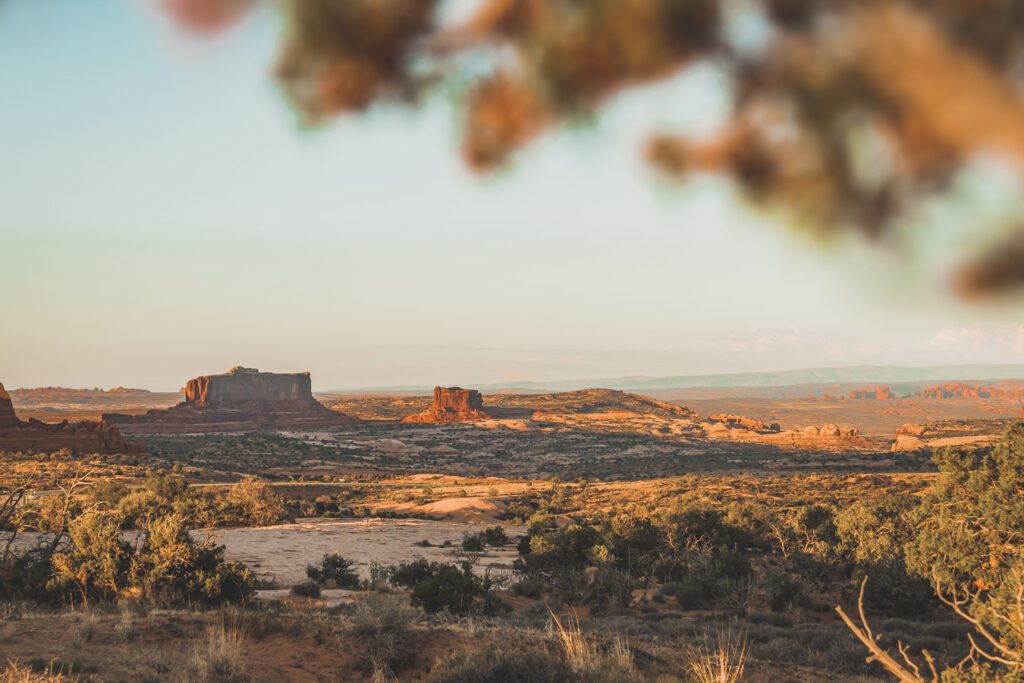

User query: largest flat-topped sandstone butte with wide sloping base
[103,367,356,434]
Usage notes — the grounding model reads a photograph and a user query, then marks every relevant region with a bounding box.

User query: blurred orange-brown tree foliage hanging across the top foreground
[157,0,1024,293]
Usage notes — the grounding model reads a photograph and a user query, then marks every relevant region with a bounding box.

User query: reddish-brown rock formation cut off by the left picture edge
[0,384,142,453]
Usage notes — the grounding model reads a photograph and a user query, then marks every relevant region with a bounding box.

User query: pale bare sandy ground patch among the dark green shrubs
[199,519,526,588]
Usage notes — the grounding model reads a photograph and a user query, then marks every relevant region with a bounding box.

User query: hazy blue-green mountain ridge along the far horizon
[317,364,1024,393]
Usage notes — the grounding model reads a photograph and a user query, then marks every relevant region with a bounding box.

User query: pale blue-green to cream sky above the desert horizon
[0,0,1024,390]
